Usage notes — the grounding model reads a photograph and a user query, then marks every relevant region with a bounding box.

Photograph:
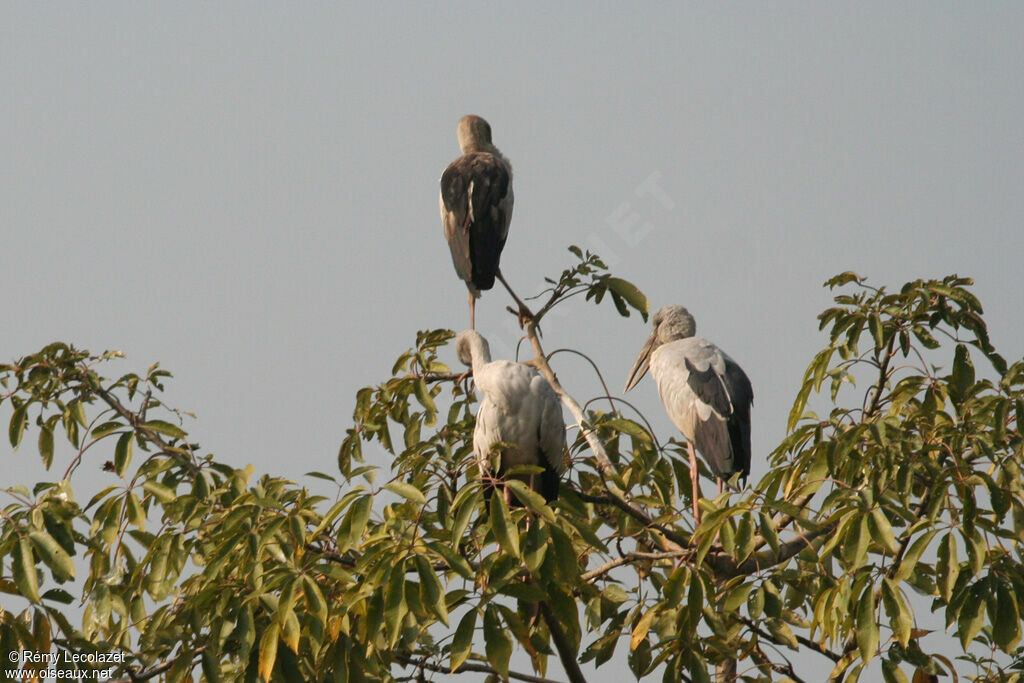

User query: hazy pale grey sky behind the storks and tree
[0,2,1024,679]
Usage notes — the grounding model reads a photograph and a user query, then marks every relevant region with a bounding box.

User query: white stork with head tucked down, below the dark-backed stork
[455,330,565,505]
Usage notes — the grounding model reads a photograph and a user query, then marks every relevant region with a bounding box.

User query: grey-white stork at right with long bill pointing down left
[626,306,754,521]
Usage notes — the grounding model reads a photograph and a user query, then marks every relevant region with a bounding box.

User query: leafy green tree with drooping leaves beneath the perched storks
[0,248,1024,682]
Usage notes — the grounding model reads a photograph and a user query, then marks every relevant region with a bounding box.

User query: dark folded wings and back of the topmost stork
[441,153,511,290]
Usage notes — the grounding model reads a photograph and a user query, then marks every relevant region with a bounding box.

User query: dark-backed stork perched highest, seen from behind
[440,115,514,330]
